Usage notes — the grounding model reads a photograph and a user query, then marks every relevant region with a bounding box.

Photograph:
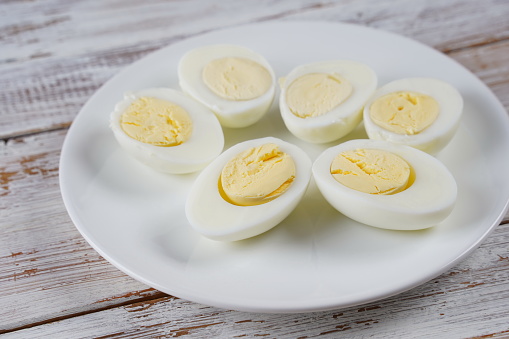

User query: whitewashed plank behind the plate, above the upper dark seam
[0,0,509,139]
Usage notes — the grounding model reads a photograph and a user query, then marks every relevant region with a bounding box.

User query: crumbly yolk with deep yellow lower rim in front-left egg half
[219,143,295,206]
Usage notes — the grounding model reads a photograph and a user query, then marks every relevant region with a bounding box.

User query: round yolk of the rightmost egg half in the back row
[370,92,440,135]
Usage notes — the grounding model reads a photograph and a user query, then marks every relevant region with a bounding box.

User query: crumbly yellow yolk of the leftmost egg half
[120,97,193,147]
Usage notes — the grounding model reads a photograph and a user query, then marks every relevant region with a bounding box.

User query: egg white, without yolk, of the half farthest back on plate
[178,45,276,128]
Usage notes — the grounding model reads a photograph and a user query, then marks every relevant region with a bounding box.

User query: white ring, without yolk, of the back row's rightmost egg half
[364,78,463,154]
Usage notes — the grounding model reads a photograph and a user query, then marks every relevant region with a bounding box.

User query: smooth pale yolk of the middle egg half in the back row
[286,73,352,118]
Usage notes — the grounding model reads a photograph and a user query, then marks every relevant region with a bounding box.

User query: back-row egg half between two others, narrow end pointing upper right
[279,60,377,143]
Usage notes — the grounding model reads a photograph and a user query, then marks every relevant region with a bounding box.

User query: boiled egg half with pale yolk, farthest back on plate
[178,45,275,128]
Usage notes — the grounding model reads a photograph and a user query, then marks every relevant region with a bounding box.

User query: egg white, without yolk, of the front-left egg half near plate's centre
[185,137,311,241]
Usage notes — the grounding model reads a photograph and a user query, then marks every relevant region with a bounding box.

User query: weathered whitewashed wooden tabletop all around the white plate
[0,0,509,338]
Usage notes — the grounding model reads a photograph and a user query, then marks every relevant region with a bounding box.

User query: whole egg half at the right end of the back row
[363,78,463,154]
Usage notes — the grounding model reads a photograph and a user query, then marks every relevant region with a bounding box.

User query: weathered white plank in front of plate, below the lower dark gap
[1,225,509,338]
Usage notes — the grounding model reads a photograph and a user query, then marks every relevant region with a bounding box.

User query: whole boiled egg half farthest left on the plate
[110,88,224,174]
